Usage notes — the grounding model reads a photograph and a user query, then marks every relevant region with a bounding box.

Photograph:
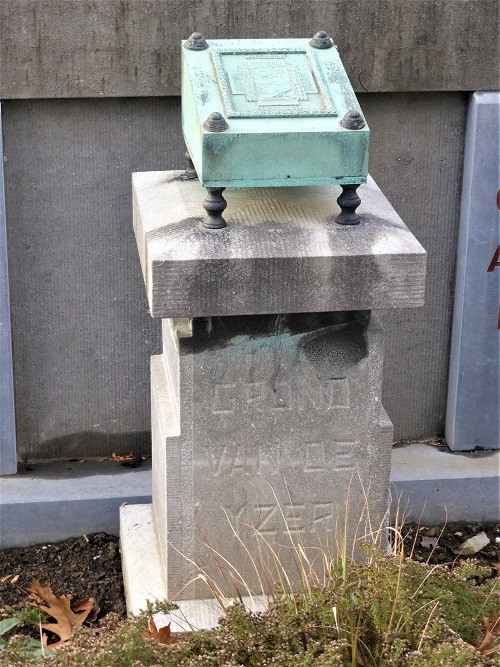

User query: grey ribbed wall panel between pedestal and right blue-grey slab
[360,93,466,440]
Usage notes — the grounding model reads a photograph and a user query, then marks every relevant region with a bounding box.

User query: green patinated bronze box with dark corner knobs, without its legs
[182,32,370,228]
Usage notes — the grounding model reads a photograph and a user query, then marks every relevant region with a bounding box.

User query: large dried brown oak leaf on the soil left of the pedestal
[28,579,93,648]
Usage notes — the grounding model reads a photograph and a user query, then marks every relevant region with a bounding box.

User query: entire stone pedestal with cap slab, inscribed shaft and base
[121,172,425,611]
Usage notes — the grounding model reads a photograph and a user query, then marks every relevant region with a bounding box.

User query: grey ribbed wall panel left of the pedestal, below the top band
[5,99,183,459]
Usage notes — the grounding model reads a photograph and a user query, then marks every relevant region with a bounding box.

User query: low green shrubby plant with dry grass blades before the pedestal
[165,553,499,667]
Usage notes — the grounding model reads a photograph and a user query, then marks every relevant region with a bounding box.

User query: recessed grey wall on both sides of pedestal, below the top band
[3,94,466,459]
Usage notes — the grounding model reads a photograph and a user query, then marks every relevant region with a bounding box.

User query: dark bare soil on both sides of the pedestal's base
[0,523,500,618]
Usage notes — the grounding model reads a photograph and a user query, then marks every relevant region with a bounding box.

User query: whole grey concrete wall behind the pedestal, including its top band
[0,0,492,459]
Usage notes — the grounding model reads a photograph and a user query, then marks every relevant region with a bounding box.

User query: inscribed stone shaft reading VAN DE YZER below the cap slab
[152,313,392,599]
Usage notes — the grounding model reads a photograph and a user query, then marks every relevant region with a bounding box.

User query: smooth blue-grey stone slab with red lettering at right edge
[446,92,500,450]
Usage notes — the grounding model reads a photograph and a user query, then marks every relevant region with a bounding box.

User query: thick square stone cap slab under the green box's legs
[132,171,426,318]
